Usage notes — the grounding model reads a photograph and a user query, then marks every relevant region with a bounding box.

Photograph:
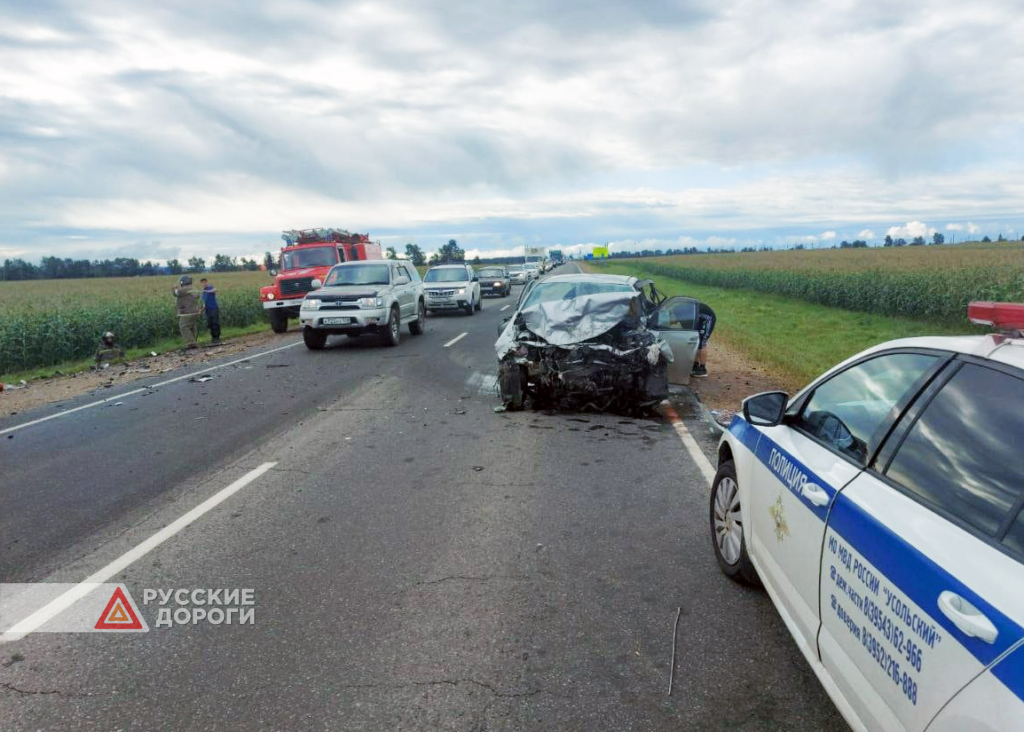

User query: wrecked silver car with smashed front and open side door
[495,274,698,415]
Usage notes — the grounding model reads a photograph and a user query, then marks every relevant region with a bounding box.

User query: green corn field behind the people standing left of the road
[0,272,270,374]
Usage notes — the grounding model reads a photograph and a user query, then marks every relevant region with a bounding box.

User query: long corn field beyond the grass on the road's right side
[598,243,1024,324]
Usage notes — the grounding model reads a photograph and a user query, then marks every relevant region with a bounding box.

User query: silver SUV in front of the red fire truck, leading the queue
[299,259,427,350]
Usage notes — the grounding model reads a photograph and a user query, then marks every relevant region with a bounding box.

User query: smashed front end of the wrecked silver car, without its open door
[495,282,673,415]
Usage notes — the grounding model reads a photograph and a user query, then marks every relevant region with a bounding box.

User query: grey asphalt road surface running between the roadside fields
[0,266,846,732]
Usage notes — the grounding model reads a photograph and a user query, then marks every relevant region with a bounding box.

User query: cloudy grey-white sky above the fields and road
[0,0,1024,260]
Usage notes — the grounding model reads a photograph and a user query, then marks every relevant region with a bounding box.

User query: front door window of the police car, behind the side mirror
[795,353,936,465]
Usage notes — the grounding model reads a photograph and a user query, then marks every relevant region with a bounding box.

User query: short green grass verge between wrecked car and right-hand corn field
[586,263,974,388]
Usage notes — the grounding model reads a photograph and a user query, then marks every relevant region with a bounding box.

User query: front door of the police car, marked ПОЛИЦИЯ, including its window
[744,353,938,655]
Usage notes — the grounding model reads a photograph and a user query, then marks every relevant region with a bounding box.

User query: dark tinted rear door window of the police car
[886,363,1024,541]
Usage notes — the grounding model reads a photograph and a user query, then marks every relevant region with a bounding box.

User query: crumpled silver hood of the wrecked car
[495,292,641,358]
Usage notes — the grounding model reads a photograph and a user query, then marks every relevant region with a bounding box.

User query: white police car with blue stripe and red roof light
[711,303,1024,732]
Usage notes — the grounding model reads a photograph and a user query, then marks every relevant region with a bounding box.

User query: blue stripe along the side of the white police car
[729,416,1024,700]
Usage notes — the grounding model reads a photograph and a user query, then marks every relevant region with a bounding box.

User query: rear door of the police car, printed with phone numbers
[819,356,1024,732]
